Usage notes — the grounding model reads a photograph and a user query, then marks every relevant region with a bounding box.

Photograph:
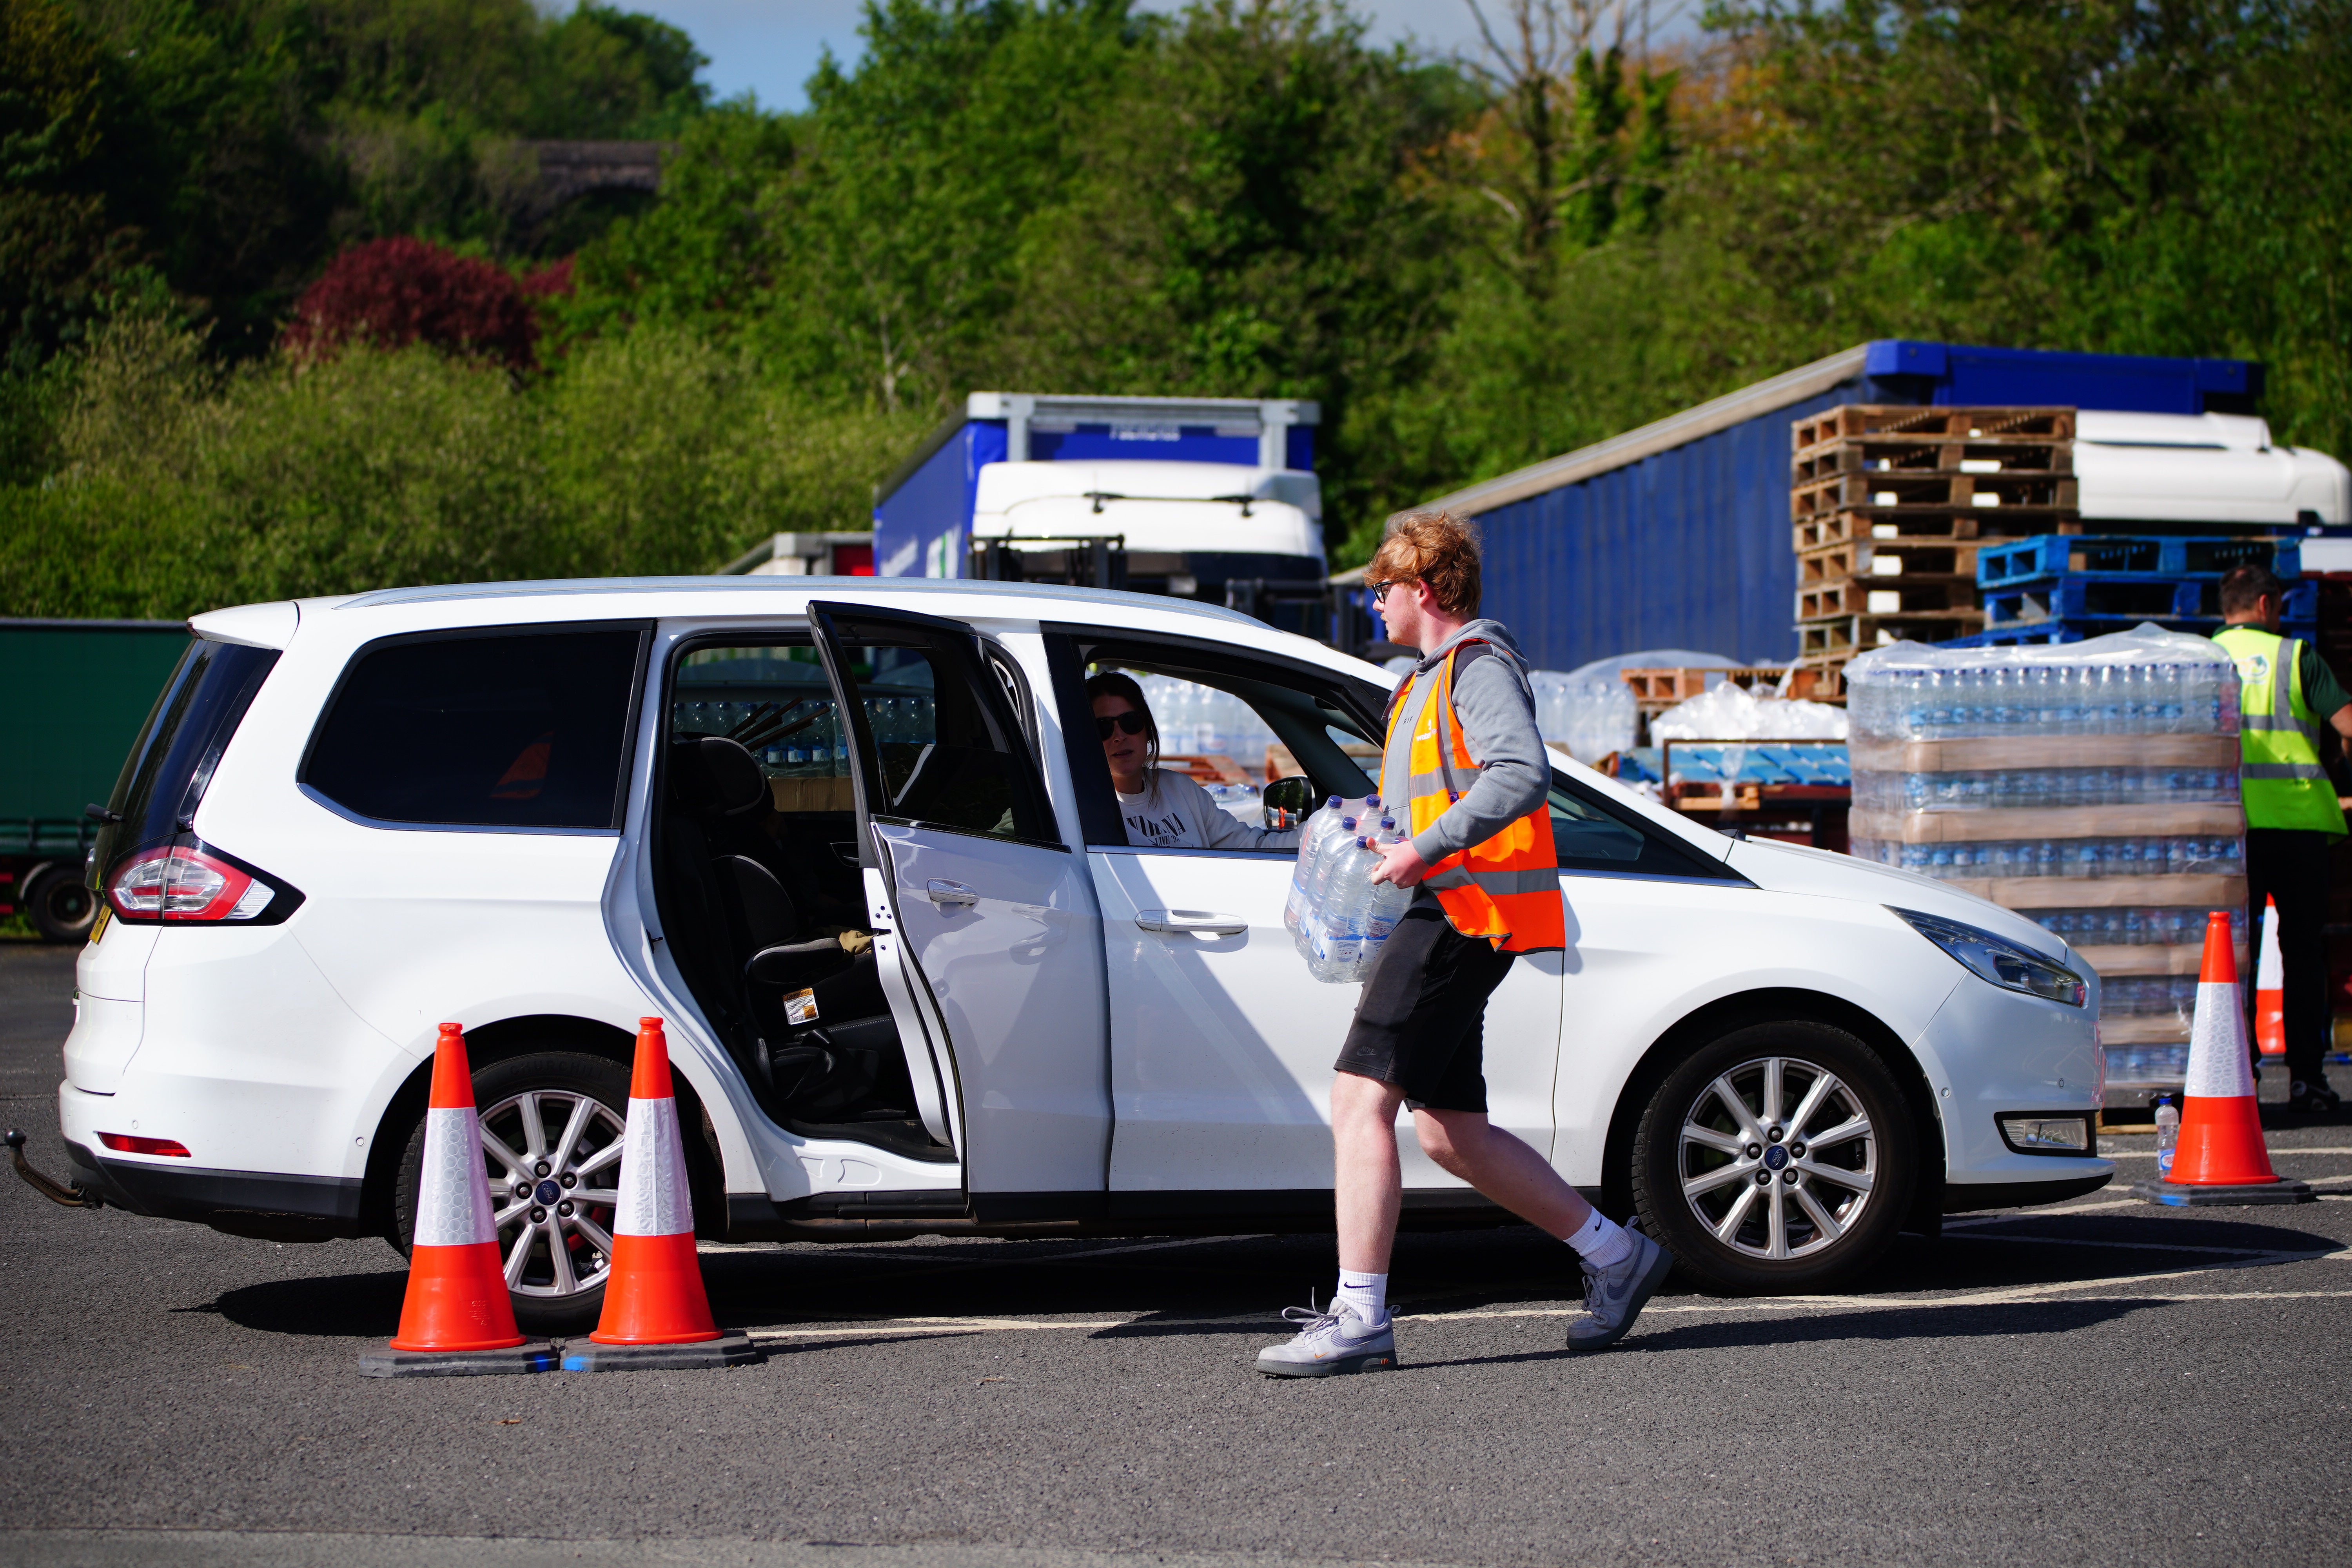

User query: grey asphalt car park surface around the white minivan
[0,945,2352,1568]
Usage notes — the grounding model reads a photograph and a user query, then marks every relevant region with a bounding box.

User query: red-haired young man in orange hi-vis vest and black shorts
[1258,512,1675,1377]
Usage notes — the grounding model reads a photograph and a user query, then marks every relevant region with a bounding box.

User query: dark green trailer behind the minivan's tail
[0,618,188,943]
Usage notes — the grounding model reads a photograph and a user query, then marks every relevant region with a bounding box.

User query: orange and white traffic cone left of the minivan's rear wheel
[360,1023,553,1377]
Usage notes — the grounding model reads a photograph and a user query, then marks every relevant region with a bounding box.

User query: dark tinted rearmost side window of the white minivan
[301,625,644,830]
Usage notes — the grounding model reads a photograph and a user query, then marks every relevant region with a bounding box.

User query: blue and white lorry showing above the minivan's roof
[873,392,1329,618]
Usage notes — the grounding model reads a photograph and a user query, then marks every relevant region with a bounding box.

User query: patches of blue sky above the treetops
[621,0,1670,108]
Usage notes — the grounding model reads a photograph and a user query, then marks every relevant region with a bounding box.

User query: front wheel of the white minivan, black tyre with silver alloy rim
[1632,1018,1919,1295]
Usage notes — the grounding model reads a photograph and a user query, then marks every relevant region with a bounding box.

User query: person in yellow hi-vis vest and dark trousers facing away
[2213,566,2352,1112]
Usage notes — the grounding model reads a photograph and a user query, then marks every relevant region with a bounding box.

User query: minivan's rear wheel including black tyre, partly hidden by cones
[393,1051,628,1333]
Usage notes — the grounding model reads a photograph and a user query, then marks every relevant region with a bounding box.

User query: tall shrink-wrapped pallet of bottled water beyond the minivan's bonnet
[1846,625,2246,1103]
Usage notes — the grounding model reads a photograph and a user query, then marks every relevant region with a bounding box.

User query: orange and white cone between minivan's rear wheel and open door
[564,1018,755,1373]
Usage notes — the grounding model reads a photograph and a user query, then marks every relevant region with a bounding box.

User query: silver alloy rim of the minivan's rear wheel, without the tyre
[482,1089,626,1300]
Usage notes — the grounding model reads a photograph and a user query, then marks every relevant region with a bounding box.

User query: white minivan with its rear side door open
[59,578,2112,1333]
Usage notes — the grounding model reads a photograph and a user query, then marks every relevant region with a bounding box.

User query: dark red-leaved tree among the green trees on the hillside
[285,238,539,369]
